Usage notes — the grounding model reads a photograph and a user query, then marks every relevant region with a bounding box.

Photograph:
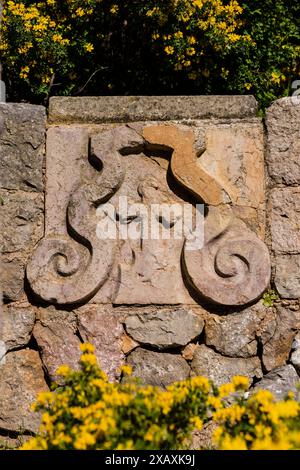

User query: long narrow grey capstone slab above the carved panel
[49,95,257,123]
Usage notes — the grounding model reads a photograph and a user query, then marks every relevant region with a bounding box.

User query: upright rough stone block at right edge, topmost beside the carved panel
[266,97,300,185]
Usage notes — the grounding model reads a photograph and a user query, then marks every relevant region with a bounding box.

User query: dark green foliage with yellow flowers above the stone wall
[0,0,300,106]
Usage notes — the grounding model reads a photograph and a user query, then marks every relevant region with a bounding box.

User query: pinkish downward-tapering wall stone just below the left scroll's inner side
[77,305,124,381]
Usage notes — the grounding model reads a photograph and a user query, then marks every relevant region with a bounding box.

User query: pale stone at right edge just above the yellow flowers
[254,364,299,400]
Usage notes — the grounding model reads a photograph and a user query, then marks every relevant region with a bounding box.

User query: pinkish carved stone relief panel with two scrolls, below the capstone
[27,124,270,305]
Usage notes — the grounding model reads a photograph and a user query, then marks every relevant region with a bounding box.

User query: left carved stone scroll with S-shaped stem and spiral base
[27,126,143,305]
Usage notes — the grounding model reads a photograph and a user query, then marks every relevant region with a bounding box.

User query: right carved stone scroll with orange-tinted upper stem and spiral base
[143,125,271,306]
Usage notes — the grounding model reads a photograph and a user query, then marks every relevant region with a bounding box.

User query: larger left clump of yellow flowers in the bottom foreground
[22,344,218,450]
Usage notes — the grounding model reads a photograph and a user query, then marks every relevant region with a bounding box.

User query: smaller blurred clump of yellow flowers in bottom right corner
[213,390,300,450]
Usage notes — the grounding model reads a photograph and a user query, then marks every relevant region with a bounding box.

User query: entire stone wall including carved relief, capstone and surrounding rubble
[0,96,300,443]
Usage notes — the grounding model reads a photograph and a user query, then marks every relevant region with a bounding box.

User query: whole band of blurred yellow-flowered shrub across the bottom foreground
[21,344,300,450]
